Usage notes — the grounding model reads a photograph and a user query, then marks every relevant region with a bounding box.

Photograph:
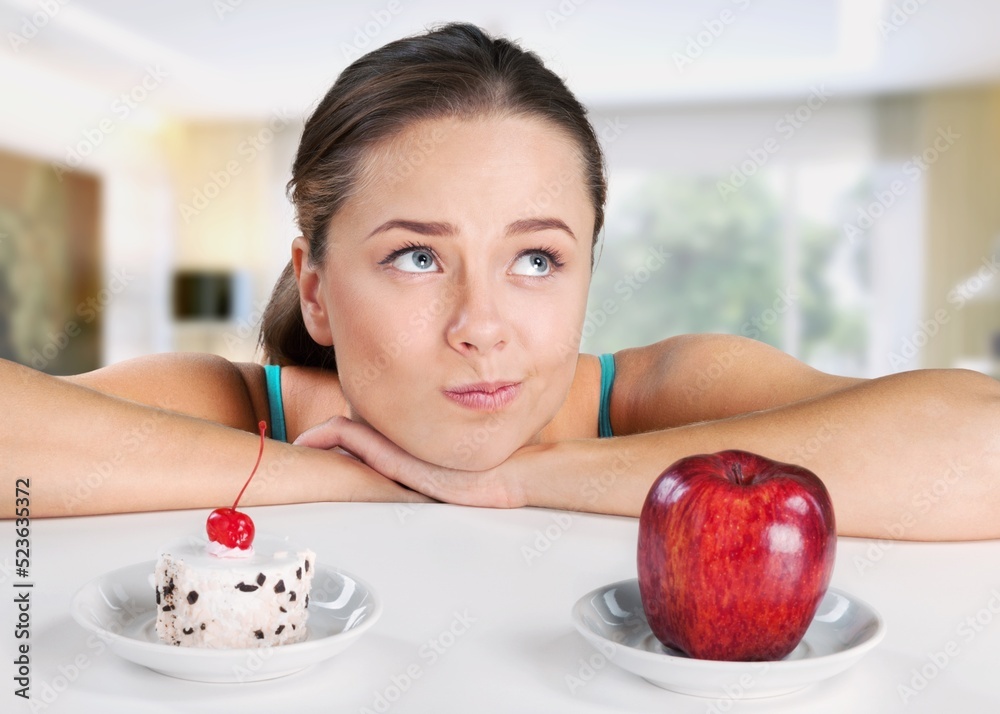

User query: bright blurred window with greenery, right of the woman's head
[583,160,872,375]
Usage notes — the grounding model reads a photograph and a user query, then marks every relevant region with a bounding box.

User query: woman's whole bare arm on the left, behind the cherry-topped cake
[0,358,424,518]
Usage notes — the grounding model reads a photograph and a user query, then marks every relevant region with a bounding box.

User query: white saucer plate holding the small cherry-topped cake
[71,560,382,682]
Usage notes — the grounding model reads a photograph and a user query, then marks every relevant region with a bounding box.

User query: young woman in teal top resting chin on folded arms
[0,25,1000,539]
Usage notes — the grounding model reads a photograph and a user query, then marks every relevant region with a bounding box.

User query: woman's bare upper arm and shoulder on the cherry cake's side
[63,352,267,431]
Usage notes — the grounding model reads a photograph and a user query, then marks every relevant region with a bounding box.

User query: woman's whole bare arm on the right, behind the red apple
[511,337,1000,539]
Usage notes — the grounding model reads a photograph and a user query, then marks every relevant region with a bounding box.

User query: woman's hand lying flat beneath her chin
[294,416,526,508]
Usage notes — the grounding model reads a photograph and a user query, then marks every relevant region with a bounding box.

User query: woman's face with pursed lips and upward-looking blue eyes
[297,117,594,470]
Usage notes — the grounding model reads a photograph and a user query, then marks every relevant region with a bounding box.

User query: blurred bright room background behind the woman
[0,0,1000,376]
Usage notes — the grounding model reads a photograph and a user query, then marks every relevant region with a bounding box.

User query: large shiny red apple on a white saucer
[638,451,837,661]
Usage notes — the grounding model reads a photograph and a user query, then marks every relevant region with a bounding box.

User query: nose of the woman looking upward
[447,279,509,355]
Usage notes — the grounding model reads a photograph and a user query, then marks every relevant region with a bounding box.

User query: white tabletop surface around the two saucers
[0,504,1000,714]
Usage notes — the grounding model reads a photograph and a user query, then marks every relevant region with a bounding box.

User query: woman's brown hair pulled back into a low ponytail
[260,23,607,369]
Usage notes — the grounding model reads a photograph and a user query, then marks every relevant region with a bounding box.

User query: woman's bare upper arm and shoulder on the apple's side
[611,334,861,434]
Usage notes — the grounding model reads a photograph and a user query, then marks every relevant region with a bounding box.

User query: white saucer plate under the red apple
[572,579,885,699]
